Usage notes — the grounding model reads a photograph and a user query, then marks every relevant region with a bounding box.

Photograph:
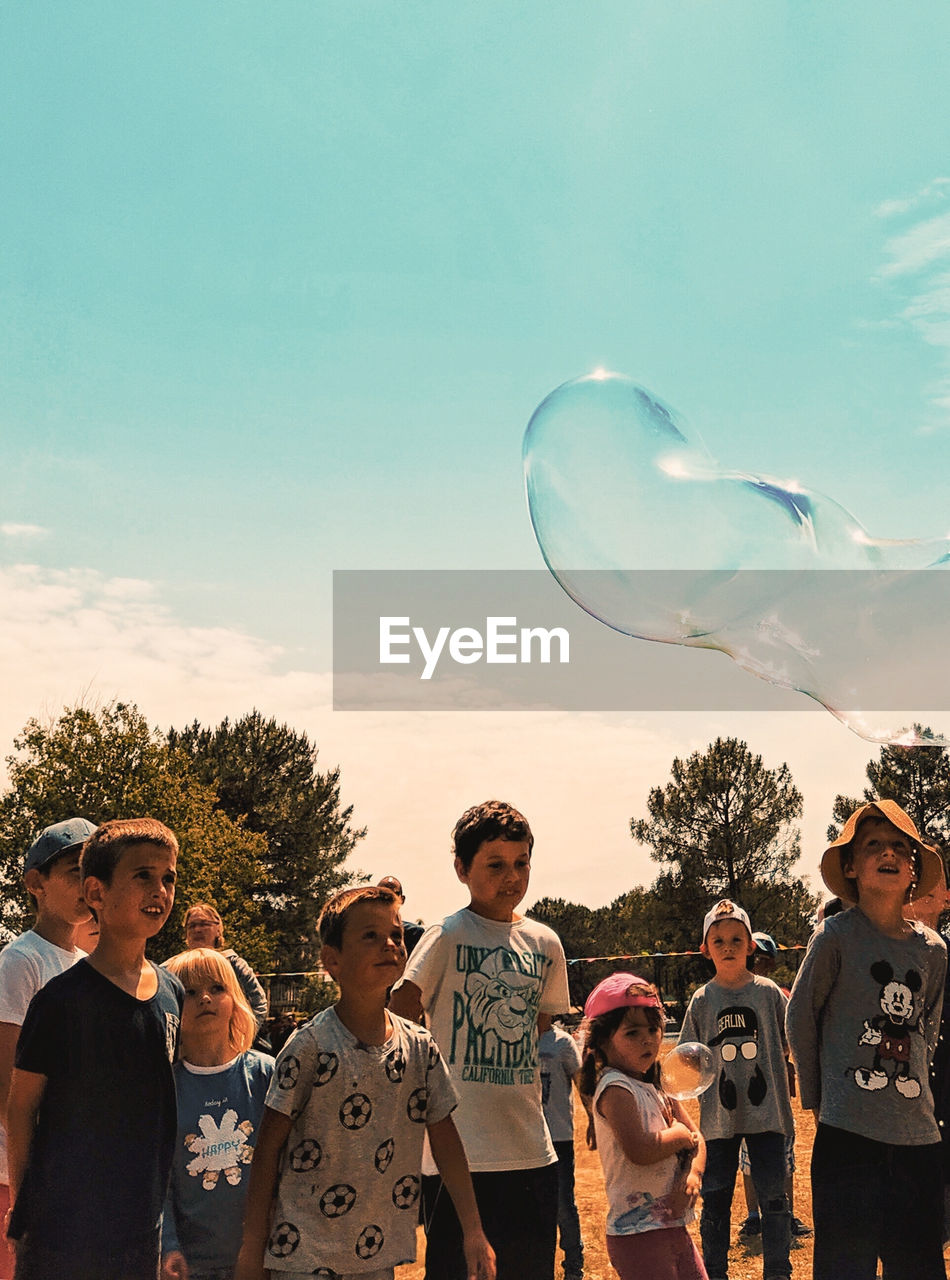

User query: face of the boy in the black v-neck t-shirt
[85,844,175,941]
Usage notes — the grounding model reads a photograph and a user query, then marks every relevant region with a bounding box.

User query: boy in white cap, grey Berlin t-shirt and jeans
[680,899,793,1280]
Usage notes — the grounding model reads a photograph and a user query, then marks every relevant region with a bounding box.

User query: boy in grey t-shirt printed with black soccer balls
[234,884,494,1280]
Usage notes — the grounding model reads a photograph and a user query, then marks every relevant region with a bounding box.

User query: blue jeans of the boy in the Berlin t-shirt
[699,1133,791,1280]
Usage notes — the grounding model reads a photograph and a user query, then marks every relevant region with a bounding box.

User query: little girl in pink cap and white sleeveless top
[581,973,707,1280]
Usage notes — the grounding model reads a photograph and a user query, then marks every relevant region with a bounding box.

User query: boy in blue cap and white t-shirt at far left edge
[0,818,96,1280]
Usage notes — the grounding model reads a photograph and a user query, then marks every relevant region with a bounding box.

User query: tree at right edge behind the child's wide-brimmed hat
[828,724,950,859]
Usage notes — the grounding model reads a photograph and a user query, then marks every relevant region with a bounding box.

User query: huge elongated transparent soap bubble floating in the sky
[524,372,950,745]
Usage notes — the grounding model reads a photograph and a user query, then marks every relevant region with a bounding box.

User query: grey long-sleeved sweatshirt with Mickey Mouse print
[787,906,946,1147]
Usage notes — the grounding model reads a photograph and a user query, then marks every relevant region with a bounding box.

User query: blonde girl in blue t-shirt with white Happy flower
[161,947,274,1280]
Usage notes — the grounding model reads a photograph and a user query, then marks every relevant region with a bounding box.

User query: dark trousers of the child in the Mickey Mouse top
[812,1124,946,1280]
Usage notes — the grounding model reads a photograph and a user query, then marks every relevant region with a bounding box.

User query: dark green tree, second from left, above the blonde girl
[168,710,366,970]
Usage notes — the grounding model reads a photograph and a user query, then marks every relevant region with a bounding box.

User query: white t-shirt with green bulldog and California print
[403,908,570,1174]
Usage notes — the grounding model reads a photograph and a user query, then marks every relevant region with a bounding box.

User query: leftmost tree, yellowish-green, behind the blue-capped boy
[0,701,274,968]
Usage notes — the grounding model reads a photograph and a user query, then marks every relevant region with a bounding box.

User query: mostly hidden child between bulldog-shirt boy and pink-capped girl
[538,1023,584,1280]
